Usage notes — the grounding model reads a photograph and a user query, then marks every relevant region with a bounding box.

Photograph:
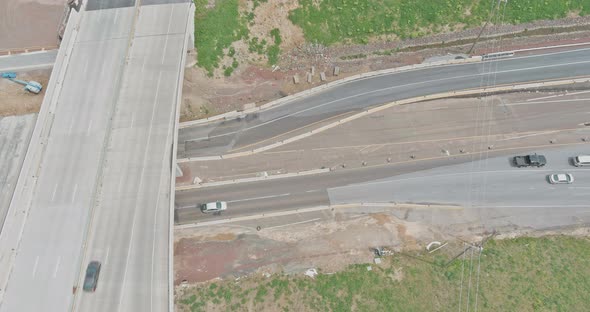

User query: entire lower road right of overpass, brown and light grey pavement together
[176,145,590,226]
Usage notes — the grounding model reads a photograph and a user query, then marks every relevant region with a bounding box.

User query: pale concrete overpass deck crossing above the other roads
[0,0,189,311]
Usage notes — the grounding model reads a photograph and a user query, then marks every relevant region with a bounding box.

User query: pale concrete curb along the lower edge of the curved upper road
[177,77,590,163]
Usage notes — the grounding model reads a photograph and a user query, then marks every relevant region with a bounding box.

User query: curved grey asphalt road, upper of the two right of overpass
[178,48,590,158]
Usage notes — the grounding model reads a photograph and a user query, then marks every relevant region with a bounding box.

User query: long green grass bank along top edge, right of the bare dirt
[289,0,590,45]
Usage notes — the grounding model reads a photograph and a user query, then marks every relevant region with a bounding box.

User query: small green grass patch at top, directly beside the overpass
[194,0,248,76]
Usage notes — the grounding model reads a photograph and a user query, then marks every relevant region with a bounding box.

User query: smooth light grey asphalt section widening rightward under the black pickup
[329,145,590,210]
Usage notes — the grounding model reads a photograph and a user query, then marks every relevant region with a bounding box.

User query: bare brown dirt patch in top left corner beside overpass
[0,0,66,51]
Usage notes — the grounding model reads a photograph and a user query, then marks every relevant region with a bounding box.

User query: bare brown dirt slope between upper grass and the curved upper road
[181,10,590,121]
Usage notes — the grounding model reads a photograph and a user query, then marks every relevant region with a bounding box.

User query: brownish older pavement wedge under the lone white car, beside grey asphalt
[176,146,552,224]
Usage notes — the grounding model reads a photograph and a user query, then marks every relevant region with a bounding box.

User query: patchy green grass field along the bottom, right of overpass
[178,236,590,311]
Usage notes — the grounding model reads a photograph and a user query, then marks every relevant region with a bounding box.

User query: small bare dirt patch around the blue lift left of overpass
[0,69,51,116]
